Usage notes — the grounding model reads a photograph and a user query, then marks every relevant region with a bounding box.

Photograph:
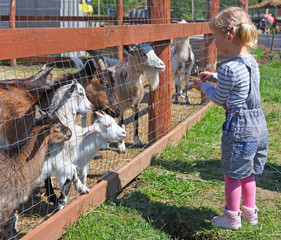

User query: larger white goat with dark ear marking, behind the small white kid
[37,80,92,206]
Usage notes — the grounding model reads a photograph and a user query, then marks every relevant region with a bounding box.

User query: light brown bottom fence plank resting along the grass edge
[21,103,213,240]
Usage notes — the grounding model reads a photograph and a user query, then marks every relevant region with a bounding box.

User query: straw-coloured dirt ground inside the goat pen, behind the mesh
[0,62,203,237]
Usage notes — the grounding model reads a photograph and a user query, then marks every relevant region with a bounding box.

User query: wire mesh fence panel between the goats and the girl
[0,0,236,238]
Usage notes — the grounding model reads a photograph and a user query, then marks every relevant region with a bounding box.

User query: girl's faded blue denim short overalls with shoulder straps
[221,56,268,179]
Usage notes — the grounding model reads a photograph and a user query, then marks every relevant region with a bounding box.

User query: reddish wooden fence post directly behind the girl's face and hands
[201,0,220,103]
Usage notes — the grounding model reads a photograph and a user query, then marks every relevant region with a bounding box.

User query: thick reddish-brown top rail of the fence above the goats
[0,22,210,60]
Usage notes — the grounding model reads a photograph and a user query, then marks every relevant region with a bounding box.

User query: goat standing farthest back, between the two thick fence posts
[171,20,194,104]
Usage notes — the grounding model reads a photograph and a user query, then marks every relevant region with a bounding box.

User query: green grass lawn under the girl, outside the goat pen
[62,59,281,240]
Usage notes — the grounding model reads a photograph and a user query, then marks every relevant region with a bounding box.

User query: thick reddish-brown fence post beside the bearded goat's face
[147,0,172,143]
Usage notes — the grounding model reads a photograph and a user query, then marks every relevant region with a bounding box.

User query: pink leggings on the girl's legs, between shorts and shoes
[224,175,256,212]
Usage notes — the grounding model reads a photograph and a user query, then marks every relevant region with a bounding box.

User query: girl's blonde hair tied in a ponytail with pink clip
[210,7,258,48]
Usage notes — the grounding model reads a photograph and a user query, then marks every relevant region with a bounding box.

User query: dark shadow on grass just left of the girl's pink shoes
[112,191,215,239]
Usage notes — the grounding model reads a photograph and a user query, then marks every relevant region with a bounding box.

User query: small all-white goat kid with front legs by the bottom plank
[38,112,126,209]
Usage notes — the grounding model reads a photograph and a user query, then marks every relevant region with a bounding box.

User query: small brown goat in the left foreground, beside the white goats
[0,111,71,239]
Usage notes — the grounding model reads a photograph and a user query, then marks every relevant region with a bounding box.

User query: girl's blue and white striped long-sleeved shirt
[201,55,260,108]
